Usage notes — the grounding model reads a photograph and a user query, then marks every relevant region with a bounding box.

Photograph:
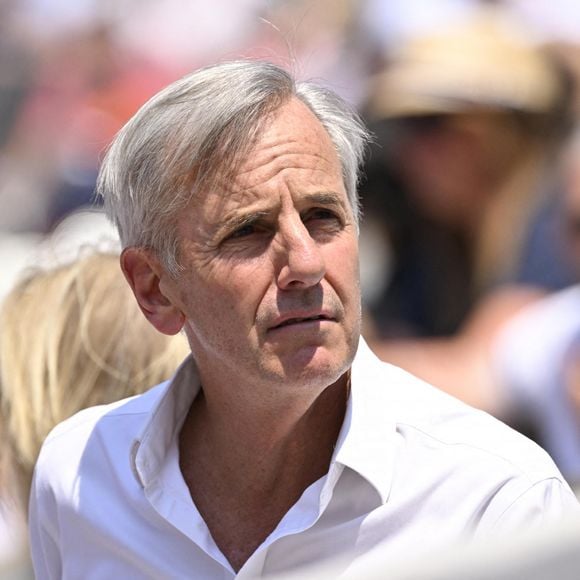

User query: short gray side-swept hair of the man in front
[97,60,369,274]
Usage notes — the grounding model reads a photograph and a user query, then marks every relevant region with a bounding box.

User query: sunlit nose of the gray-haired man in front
[277,220,326,290]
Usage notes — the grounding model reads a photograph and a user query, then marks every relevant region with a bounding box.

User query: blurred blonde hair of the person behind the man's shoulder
[0,253,188,502]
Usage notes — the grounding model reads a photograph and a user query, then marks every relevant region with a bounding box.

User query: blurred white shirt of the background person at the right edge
[491,285,580,483]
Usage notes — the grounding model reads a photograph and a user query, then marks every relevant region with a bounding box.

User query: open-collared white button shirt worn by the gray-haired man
[30,341,580,580]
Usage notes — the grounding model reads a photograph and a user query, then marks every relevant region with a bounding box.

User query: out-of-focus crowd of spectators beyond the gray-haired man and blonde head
[0,0,580,576]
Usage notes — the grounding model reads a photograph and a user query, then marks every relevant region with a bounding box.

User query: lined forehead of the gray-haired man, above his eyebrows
[177,99,349,245]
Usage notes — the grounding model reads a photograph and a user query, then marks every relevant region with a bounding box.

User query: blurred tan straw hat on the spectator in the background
[369,10,561,119]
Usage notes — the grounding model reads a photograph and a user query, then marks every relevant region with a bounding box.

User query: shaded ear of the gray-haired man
[121,248,185,335]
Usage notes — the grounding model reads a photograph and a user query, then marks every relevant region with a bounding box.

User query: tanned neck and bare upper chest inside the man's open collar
[179,374,349,570]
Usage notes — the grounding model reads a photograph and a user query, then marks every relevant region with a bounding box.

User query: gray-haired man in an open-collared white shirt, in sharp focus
[30,62,578,578]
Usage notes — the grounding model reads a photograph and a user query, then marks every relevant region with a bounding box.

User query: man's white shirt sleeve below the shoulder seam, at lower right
[492,478,580,532]
